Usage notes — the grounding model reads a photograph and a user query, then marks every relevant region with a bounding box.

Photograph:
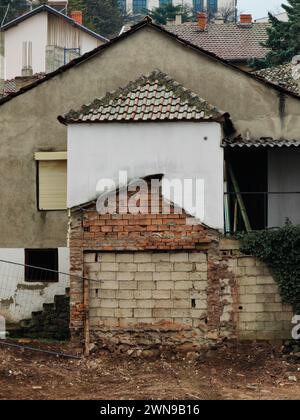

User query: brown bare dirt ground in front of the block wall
[0,342,300,400]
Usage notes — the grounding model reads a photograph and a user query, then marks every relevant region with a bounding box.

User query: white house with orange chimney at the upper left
[0,5,107,80]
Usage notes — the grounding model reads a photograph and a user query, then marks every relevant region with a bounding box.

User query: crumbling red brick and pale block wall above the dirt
[69,188,292,347]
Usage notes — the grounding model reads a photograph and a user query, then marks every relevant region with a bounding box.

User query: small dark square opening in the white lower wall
[25,249,58,283]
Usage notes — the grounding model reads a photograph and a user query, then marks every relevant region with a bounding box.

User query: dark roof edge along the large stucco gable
[0,16,300,106]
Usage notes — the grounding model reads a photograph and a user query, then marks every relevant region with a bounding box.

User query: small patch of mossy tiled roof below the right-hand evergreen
[255,63,300,94]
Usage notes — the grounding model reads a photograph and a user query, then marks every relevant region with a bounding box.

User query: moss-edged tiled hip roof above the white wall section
[59,70,223,123]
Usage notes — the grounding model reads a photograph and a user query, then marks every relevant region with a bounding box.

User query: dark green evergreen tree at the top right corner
[251,0,300,69]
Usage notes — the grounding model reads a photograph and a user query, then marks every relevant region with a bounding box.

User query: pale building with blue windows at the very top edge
[119,0,235,14]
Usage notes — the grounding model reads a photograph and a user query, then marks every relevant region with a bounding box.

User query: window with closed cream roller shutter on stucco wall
[35,152,67,210]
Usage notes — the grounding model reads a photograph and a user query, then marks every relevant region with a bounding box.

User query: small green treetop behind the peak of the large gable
[145,3,193,25]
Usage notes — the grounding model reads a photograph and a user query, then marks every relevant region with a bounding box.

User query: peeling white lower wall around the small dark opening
[0,248,69,323]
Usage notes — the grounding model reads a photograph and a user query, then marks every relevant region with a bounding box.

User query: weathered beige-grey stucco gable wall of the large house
[0,27,300,248]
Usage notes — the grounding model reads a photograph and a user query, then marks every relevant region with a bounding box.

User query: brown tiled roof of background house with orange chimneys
[165,22,269,61]
